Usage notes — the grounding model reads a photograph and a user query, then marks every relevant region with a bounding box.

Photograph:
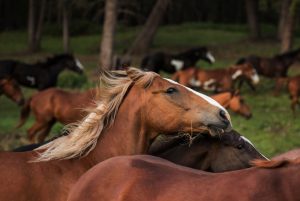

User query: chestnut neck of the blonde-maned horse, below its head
[86,89,150,165]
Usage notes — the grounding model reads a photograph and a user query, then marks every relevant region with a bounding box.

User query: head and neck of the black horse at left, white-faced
[46,54,84,74]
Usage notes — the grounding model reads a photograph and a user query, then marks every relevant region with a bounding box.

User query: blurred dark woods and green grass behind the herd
[0,0,300,157]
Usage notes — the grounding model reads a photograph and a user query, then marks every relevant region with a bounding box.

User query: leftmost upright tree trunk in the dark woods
[28,0,35,52]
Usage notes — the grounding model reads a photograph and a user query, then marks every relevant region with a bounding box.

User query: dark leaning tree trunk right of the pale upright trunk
[126,0,171,56]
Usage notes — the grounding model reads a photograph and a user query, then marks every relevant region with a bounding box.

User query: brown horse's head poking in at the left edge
[0,78,25,105]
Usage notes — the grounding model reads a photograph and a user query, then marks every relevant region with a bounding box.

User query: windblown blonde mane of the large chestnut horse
[34,68,157,162]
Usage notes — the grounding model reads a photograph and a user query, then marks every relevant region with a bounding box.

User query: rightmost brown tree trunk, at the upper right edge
[281,0,299,52]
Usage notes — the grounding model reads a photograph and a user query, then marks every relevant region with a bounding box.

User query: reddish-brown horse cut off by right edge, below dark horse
[288,75,300,116]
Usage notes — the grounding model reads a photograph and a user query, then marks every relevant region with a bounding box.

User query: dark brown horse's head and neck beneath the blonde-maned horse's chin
[148,130,266,172]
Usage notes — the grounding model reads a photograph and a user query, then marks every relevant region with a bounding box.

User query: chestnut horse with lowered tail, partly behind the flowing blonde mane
[17,88,96,143]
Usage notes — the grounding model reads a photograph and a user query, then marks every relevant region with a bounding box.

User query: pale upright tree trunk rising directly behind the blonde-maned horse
[100,0,118,69]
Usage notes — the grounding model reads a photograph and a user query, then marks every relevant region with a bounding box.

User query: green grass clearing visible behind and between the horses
[0,23,300,157]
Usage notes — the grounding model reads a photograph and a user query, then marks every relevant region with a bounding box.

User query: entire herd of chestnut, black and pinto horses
[0,47,300,201]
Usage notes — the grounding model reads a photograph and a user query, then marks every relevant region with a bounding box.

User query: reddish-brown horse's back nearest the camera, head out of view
[67,155,300,201]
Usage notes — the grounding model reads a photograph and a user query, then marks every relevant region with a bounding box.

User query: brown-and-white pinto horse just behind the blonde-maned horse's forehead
[172,63,259,92]
